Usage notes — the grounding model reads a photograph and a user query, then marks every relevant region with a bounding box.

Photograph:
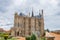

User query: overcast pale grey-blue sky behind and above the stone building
[0,0,60,30]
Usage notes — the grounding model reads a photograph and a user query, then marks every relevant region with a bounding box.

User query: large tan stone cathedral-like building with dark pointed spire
[11,10,44,37]
